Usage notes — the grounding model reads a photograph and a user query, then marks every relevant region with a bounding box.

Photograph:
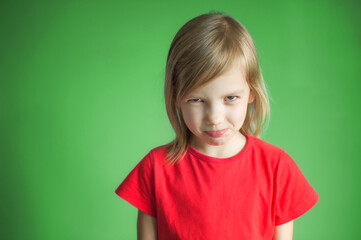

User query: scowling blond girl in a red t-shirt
[116,12,319,240]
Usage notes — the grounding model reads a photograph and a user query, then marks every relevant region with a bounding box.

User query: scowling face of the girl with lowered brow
[181,60,254,154]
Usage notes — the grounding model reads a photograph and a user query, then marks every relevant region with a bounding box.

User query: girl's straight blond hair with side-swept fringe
[164,12,270,165]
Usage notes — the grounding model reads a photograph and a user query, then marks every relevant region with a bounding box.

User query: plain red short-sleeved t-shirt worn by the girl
[115,134,319,240]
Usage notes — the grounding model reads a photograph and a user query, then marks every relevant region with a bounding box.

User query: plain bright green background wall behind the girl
[0,0,361,240]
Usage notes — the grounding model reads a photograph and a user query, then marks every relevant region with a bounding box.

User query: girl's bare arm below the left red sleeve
[137,209,158,240]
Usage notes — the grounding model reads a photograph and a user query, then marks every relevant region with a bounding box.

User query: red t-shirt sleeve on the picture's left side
[115,152,157,217]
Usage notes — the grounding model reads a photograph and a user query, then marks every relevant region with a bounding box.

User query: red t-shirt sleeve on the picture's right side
[275,150,319,225]
